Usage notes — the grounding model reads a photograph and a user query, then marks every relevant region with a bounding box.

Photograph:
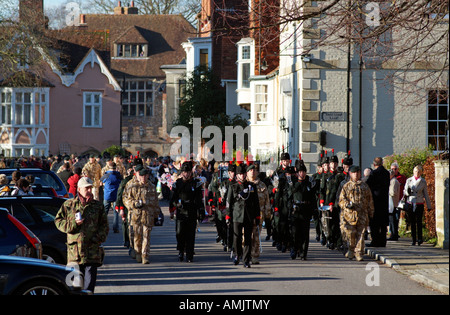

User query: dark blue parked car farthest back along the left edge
[0,168,73,198]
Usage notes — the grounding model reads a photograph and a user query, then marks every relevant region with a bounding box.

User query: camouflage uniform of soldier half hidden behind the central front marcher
[250,178,271,263]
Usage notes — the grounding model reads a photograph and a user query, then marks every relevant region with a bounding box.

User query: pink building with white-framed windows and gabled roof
[0,1,121,156]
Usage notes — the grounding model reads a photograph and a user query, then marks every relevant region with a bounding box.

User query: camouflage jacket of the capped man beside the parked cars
[55,197,109,266]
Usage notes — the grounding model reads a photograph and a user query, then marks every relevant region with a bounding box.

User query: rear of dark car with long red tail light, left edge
[0,208,42,258]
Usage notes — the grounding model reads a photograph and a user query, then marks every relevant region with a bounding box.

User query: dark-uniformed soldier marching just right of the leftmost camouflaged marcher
[169,161,205,262]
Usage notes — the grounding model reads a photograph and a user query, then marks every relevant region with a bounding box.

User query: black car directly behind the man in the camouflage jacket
[0,196,67,265]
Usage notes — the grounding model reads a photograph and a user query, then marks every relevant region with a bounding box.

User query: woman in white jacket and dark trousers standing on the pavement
[403,165,431,246]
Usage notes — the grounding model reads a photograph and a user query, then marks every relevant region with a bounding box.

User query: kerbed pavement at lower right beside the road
[365,236,449,294]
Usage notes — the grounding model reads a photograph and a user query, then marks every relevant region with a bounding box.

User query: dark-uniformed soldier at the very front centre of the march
[225,164,261,268]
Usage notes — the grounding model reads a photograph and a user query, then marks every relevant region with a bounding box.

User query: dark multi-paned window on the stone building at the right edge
[427,90,449,151]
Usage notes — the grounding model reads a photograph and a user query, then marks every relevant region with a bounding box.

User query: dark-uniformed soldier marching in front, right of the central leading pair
[290,160,317,260]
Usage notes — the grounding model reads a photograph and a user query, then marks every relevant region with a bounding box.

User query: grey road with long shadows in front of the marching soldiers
[95,207,439,296]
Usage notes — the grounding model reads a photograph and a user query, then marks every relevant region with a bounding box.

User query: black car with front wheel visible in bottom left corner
[0,256,92,295]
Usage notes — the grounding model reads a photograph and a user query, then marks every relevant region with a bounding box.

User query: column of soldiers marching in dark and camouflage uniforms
[107,152,373,268]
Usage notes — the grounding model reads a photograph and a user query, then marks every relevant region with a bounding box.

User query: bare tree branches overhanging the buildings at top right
[209,0,449,103]
